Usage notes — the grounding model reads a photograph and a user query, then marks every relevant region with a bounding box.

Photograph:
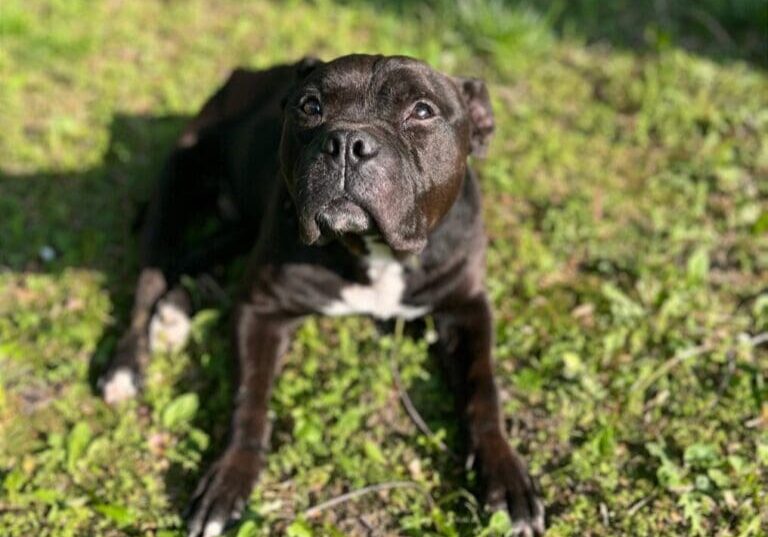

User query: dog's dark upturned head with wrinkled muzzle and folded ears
[280,55,494,252]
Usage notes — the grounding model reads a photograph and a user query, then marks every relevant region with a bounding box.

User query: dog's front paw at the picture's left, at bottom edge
[186,449,261,537]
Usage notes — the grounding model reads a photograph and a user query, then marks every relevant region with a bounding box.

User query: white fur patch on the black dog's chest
[321,241,429,319]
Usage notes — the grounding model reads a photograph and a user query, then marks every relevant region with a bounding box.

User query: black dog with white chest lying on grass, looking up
[101,55,544,537]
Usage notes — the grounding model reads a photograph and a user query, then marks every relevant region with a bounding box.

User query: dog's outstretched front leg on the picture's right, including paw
[434,294,544,537]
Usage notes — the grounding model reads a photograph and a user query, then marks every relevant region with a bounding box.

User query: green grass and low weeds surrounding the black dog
[0,0,768,537]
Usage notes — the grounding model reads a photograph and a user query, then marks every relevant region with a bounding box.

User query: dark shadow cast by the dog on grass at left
[0,115,237,510]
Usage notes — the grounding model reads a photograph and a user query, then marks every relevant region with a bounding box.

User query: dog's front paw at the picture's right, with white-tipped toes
[478,435,544,537]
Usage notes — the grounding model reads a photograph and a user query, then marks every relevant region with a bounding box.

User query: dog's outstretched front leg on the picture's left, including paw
[188,305,297,537]
